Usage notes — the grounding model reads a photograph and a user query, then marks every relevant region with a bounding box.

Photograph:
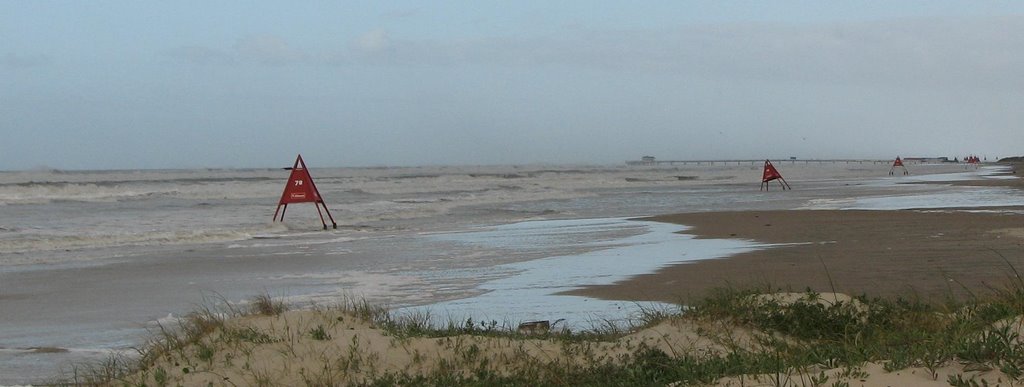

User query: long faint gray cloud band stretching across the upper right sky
[346,16,1024,87]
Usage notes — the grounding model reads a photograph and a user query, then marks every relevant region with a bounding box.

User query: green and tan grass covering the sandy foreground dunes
[48,272,1024,386]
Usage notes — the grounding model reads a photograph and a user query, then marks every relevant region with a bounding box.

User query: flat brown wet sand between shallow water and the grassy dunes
[567,164,1024,303]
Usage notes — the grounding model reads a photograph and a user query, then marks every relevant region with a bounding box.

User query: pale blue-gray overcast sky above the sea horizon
[0,0,1024,170]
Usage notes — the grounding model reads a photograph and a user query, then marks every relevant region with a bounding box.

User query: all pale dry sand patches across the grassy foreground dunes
[122,293,1021,386]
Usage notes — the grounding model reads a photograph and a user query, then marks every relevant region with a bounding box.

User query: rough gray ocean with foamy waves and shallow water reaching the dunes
[0,161,1024,384]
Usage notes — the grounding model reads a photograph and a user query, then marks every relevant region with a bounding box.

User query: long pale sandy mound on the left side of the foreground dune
[126,309,755,386]
